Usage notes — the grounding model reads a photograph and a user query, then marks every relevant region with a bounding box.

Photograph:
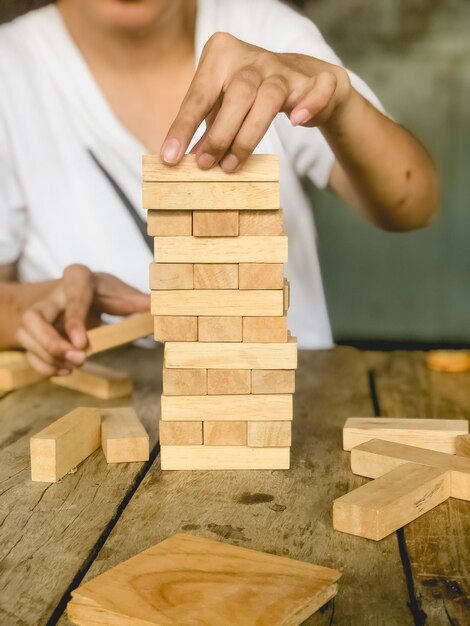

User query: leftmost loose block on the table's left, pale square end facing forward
[30,407,101,483]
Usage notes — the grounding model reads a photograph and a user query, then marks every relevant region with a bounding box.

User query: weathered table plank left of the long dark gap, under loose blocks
[0,348,162,626]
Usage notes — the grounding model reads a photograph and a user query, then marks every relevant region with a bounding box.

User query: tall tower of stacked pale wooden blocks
[143,155,297,470]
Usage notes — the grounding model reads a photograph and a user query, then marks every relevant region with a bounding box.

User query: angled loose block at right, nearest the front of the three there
[333,463,450,541]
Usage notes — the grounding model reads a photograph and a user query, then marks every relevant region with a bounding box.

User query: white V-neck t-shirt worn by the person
[0,0,380,348]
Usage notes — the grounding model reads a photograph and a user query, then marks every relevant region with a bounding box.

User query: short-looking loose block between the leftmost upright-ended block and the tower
[101,406,149,463]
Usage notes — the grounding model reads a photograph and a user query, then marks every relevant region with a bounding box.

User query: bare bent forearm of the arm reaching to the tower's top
[321,90,438,231]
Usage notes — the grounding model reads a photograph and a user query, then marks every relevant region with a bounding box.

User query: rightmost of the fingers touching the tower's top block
[221,76,288,172]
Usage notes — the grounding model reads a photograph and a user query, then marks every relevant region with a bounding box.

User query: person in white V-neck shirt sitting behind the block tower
[0,0,438,375]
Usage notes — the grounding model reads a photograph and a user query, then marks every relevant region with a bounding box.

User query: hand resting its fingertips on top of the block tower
[161,33,352,172]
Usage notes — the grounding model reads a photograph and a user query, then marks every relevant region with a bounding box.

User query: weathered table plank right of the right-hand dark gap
[376,352,470,626]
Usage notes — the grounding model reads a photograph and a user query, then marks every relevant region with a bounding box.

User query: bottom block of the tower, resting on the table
[161,446,290,470]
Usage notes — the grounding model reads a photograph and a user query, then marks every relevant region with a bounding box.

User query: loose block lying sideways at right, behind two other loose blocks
[343,417,468,454]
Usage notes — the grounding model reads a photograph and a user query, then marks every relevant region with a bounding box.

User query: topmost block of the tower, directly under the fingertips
[142,154,279,183]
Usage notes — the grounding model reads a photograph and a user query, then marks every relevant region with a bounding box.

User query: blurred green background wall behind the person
[0,0,470,345]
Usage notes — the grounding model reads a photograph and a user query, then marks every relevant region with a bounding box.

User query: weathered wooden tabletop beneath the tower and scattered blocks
[0,348,470,626]
